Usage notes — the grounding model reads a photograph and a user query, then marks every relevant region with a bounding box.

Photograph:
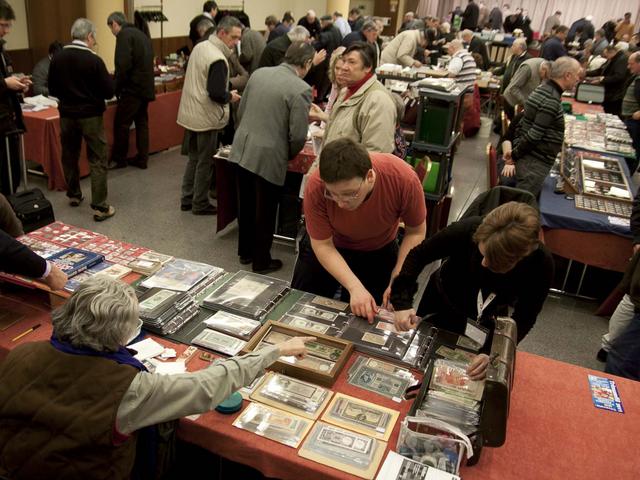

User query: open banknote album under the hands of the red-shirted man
[278,293,433,368]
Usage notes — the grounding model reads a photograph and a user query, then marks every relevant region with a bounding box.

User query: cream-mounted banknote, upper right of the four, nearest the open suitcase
[322,393,400,441]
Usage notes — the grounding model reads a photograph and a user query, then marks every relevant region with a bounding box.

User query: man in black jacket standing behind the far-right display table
[587,45,629,115]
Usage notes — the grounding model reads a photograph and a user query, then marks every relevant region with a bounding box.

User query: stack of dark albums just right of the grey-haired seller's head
[139,288,199,335]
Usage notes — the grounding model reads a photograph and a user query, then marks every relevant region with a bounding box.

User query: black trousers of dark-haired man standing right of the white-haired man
[111,95,149,165]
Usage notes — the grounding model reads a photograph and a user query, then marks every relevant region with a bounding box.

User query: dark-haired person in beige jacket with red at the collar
[309,42,397,153]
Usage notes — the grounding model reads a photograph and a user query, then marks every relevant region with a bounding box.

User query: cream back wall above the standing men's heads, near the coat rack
[134,0,330,38]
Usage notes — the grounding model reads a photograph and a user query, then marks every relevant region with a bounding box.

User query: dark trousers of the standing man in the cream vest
[181,130,218,212]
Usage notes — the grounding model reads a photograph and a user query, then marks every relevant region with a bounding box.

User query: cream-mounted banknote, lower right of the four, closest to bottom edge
[298,421,387,479]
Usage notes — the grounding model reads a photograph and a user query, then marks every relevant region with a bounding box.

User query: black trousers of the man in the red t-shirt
[291,234,398,305]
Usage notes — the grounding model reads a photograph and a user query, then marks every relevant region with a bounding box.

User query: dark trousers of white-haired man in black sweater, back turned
[60,116,109,211]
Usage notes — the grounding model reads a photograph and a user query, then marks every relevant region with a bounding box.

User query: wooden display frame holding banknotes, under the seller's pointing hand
[242,320,353,387]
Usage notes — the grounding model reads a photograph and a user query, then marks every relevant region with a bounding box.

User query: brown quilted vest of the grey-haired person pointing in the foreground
[0,342,138,480]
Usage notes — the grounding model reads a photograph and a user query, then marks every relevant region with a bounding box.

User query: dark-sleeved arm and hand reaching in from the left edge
[0,230,67,290]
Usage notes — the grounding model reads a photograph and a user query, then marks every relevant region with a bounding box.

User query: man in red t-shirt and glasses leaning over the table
[291,138,427,321]
